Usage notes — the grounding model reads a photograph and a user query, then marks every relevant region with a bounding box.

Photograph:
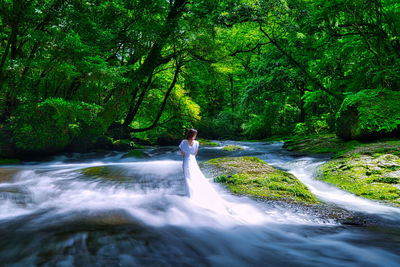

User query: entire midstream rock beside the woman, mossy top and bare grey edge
[201,157,387,225]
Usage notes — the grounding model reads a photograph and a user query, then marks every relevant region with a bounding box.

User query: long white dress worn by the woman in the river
[179,139,227,213]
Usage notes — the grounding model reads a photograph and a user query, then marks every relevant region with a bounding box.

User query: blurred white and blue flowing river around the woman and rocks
[0,141,400,266]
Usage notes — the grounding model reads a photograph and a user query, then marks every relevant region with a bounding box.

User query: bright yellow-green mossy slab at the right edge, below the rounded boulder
[317,141,400,206]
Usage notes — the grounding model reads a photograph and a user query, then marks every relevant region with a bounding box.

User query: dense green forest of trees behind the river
[0,0,400,157]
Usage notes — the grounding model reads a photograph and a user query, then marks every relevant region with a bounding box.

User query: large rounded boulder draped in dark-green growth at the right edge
[336,90,400,140]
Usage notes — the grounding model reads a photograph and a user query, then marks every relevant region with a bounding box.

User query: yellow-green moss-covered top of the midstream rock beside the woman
[205,157,318,204]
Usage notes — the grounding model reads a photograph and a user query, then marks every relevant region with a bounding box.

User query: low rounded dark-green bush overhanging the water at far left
[10,98,103,153]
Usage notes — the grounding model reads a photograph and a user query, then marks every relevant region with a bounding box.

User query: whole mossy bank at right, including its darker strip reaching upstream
[278,135,400,207]
